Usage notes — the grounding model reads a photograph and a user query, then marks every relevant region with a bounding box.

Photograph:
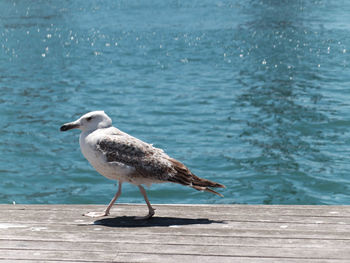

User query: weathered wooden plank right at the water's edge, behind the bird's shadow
[0,206,350,225]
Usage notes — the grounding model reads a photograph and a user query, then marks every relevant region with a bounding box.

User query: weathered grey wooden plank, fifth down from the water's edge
[0,241,350,260]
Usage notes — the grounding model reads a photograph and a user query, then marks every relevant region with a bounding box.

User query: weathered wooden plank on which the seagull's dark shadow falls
[0,213,350,233]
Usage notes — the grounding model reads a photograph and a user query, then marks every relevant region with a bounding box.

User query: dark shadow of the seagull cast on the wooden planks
[94,216,225,227]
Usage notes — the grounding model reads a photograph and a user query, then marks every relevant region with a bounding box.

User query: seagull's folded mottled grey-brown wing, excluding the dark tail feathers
[96,132,176,181]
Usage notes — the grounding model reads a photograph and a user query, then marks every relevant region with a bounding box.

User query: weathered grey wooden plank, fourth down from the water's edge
[0,238,350,251]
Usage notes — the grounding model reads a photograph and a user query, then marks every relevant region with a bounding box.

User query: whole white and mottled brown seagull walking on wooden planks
[60,111,225,219]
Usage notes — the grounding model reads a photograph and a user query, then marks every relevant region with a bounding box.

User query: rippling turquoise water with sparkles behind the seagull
[0,0,350,204]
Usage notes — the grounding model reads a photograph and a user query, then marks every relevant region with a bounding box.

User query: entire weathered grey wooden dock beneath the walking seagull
[0,204,350,263]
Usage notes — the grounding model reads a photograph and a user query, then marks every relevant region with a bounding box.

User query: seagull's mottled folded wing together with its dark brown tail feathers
[96,130,225,196]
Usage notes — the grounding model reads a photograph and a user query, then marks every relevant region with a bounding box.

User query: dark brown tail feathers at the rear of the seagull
[169,158,226,197]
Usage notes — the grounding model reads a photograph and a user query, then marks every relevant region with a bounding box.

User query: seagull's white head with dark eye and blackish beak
[60,111,112,131]
